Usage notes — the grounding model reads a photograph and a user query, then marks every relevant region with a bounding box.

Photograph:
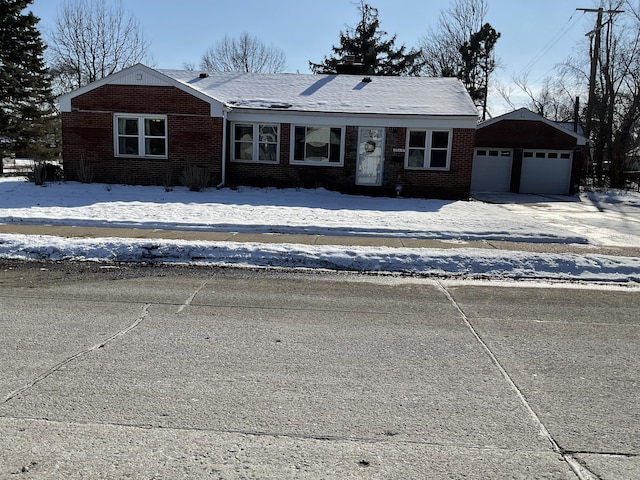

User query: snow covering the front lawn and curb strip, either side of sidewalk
[0,178,640,284]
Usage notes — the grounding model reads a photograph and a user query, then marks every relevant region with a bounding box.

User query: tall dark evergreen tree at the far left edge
[0,0,56,159]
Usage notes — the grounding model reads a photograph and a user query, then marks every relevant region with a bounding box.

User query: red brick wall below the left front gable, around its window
[62,85,222,185]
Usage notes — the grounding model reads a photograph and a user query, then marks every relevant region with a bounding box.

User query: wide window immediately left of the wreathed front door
[291,126,344,165]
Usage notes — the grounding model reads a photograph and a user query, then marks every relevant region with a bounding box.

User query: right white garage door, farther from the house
[520,150,572,195]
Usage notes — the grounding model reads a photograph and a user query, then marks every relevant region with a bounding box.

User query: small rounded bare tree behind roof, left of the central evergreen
[200,32,286,73]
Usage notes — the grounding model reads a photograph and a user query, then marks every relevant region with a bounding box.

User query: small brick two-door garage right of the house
[471,108,586,195]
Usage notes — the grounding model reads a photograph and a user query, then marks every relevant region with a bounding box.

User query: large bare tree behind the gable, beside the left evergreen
[49,0,149,93]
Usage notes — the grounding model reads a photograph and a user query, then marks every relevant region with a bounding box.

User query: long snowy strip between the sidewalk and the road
[0,235,640,283]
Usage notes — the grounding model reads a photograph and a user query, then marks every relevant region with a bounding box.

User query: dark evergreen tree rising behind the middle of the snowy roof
[309,1,422,76]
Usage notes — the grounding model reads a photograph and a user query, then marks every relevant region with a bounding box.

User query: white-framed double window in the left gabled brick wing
[114,115,167,158]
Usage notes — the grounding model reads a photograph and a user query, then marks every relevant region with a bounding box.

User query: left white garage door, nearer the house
[471,148,513,192]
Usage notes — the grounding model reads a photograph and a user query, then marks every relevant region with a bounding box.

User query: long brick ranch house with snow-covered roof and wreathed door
[59,64,477,198]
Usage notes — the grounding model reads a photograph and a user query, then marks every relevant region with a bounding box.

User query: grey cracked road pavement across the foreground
[0,262,640,479]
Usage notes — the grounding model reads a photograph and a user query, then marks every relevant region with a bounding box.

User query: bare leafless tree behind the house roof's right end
[419,0,488,77]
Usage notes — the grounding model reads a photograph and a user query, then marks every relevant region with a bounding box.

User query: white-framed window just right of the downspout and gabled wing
[233,123,279,163]
